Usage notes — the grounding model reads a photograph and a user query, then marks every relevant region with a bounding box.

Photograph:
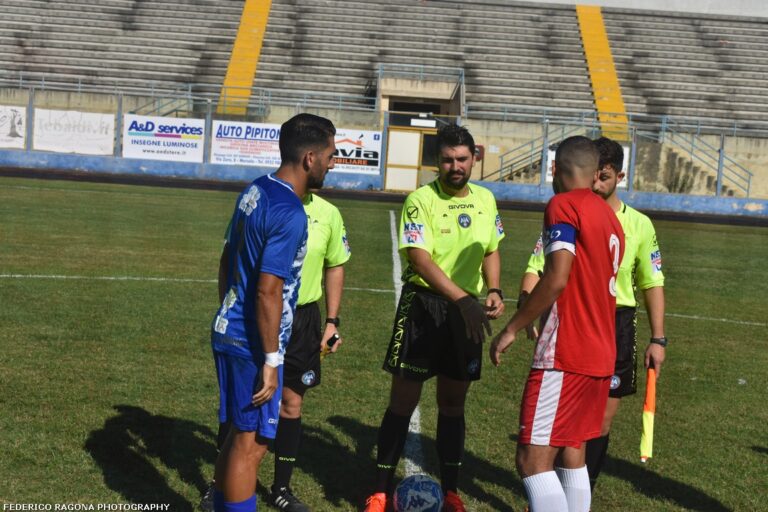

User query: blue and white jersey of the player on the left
[211,174,307,365]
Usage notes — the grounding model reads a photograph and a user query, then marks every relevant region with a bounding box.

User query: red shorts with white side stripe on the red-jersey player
[518,369,611,448]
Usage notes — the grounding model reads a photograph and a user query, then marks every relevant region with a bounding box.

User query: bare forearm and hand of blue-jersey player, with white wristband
[253,272,283,405]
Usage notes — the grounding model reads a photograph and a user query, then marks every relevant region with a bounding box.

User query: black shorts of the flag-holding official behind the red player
[608,307,637,398]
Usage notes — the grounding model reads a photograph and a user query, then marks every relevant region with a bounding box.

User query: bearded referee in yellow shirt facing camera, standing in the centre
[366,125,504,512]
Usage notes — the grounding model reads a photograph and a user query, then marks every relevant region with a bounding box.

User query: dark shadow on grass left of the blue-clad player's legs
[85,405,216,511]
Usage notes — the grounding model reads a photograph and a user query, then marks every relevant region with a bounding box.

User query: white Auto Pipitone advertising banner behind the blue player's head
[211,121,280,169]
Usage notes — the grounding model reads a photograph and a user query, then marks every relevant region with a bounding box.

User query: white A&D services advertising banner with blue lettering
[123,114,205,163]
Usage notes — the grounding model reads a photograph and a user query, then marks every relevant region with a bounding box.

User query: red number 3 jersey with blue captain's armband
[532,189,624,377]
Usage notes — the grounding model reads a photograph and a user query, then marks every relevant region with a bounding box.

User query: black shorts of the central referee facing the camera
[383,284,483,382]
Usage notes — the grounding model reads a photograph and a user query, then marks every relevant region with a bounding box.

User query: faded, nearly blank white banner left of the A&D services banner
[32,108,115,155]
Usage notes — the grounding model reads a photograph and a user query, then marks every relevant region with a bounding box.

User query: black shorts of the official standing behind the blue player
[283,302,322,393]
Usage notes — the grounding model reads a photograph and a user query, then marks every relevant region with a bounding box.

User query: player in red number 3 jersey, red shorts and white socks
[490,136,624,512]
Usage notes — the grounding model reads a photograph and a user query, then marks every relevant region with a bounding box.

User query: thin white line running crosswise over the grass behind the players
[0,274,768,327]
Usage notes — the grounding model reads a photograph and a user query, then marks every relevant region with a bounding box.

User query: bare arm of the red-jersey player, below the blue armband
[490,250,574,366]
